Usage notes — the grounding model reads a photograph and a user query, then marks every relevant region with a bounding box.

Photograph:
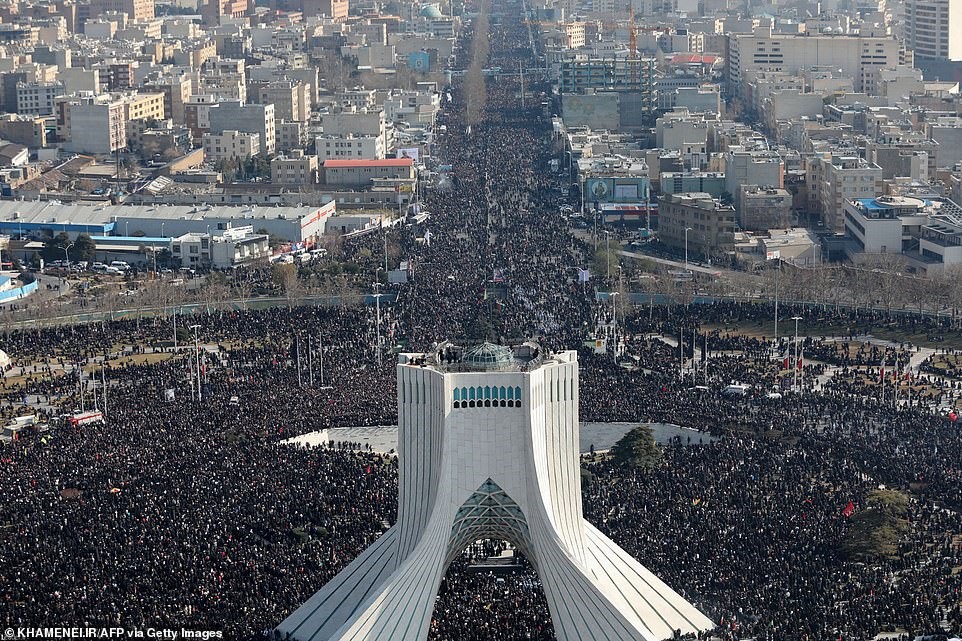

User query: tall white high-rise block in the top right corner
[905,0,962,61]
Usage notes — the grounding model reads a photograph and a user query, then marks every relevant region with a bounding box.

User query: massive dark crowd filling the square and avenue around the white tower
[0,2,962,641]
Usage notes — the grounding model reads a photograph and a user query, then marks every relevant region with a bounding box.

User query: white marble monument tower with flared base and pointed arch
[278,343,714,641]
